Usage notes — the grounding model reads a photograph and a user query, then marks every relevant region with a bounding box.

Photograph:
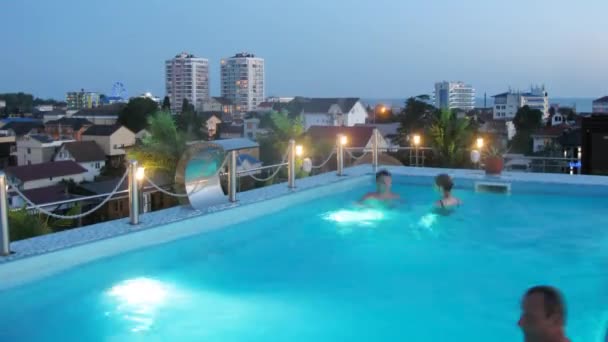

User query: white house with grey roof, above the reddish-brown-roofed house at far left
[13,134,74,166]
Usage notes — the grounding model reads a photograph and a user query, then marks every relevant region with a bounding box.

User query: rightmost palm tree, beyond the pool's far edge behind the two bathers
[429,110,473,167]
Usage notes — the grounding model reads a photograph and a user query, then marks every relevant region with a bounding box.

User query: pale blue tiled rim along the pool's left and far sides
[0,165,608,289]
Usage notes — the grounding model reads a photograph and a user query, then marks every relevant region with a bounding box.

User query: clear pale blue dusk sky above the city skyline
[0,0,608,99]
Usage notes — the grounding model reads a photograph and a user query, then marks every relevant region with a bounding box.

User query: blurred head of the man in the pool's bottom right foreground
[518,286,568,342]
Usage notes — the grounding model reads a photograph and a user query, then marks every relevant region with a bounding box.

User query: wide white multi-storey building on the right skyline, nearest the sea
[493,87,549,120]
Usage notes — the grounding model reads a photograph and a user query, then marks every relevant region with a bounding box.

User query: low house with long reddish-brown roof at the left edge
[5,160,87,190]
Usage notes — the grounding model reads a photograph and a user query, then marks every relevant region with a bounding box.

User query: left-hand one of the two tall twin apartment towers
[165,52,209,113]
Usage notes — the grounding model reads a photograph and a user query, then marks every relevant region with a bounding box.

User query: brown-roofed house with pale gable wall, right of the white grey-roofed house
[54,141,106,182]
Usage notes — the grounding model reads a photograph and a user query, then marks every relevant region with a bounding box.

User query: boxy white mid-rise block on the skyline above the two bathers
[435,81,475,111]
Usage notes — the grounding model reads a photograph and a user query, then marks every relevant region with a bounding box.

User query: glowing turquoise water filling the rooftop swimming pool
[0,180,608,342]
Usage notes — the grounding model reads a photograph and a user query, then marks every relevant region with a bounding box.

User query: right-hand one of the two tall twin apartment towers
[221,52,265,113]
